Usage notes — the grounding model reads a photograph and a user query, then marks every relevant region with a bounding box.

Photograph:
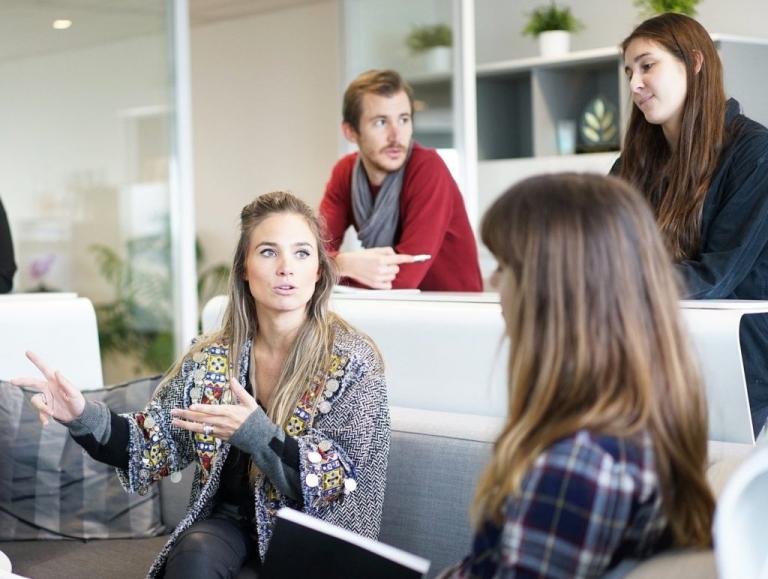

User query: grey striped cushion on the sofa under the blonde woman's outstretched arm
[0,376,164,540]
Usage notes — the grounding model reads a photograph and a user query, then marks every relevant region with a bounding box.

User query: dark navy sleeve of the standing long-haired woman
[677,131,768,299]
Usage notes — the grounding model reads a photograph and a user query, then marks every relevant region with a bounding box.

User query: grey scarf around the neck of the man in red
[352,146,413,248]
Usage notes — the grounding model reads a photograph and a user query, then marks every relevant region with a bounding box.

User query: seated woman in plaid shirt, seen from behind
[444,174,714,578]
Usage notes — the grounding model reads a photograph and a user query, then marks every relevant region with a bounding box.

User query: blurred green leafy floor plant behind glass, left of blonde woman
[90,233,229,373]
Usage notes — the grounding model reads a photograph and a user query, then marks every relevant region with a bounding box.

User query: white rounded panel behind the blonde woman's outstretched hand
[0,293,104,389]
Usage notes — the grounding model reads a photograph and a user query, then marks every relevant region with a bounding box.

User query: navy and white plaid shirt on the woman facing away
[454,430,668,577]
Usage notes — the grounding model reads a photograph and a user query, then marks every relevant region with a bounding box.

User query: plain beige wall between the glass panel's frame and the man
[191,0,341,270]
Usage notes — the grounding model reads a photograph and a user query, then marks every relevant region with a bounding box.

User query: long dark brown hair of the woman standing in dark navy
[619,13,725,260]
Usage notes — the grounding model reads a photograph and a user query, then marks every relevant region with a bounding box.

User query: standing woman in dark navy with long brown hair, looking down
[611,13,768,434]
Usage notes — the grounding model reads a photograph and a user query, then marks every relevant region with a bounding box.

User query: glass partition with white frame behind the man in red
[342,0,477,226]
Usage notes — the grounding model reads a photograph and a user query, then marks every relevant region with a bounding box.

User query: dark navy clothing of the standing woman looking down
[611,99,768,434]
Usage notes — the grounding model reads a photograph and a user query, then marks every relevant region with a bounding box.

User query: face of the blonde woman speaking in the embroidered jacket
[245,213,320,315]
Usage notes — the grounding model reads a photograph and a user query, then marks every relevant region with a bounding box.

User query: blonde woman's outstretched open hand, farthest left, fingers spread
[11,352,85,426]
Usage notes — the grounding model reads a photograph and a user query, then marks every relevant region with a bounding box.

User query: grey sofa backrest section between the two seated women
[379,407,503,577]
